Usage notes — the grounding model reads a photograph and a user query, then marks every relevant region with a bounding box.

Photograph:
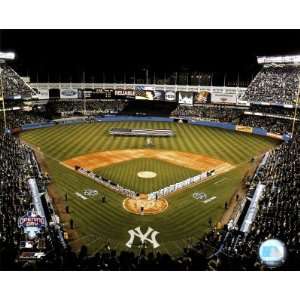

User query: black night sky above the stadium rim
[0,30,300,82]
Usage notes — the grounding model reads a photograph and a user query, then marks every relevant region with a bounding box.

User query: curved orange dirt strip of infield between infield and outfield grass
[62,149,233,173]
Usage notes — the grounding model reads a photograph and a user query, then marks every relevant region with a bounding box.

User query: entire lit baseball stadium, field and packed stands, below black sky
[0,33,300,270]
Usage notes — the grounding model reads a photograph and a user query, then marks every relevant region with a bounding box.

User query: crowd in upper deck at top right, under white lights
[243,65,300,104]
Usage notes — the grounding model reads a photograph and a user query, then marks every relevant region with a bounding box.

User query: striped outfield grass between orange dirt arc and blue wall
[22,122,276,164]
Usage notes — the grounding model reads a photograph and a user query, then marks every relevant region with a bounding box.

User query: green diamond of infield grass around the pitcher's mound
[94,158,200,193]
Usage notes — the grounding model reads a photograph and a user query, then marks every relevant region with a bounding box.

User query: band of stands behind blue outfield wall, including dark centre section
[0,99,300,134]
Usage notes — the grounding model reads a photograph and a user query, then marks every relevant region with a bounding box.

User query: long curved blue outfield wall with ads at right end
[17,115,291,141]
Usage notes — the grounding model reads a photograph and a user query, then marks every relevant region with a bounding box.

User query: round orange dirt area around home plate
[123,195,168,215]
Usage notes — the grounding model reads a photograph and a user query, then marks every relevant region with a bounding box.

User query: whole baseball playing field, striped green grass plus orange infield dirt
[21,121,278,255]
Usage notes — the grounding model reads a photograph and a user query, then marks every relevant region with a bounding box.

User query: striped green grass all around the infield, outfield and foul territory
[21,122,278,255]
